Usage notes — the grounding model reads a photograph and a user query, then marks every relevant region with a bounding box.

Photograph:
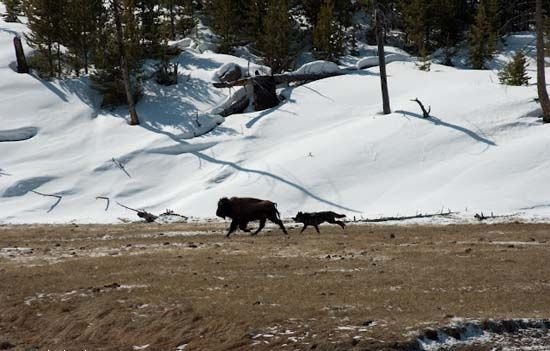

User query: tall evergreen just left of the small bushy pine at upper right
[468,0,497,69]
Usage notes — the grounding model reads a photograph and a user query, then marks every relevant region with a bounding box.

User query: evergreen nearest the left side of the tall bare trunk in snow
[312,0,345,61]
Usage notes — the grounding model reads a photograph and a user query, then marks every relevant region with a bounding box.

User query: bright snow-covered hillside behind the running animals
[0,13,550,223]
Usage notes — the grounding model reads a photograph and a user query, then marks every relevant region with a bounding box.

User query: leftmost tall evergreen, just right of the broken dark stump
[24,0,66,78]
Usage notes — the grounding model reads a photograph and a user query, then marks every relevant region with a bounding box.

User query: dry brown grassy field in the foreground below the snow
[0,223,550,351]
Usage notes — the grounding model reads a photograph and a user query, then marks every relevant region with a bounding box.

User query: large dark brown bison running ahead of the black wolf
[216,197,288,237]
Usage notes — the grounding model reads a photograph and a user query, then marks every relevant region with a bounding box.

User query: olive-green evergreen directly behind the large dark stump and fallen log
[258,0,294,73]
